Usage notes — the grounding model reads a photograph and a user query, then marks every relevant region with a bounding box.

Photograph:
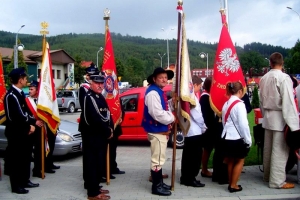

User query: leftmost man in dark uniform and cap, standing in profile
[4,68,39,194]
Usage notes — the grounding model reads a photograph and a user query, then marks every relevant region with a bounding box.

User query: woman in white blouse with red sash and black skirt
[222,82,252,192]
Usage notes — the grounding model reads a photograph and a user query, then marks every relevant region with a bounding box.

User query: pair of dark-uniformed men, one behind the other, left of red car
[79,63,125,200]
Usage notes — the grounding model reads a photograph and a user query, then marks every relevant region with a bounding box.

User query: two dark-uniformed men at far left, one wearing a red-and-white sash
[4,68,60,194]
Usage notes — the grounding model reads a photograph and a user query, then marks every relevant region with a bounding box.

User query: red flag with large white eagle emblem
[210,10,246,116]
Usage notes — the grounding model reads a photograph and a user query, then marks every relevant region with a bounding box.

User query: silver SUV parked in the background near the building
[56,90,80,113]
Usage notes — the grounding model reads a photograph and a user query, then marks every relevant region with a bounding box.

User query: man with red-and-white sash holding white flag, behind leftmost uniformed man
[25,80,60,178]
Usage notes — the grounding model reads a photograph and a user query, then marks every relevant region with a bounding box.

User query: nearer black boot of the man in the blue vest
[151,169,172,196]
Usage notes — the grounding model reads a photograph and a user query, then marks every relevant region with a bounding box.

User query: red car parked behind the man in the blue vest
[119,85,184,148]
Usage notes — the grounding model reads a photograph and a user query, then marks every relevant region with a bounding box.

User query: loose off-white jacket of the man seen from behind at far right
[259,69,299,131]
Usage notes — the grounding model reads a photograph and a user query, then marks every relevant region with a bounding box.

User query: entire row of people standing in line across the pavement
[4,53,299,200]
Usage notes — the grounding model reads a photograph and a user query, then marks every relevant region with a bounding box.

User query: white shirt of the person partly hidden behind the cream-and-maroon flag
[186,96,207,137]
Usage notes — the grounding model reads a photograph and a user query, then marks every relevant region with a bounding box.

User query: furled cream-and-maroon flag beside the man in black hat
[173,5,196,135]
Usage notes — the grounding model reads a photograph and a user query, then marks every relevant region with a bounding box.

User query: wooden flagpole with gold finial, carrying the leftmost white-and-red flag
[39,22,49,179]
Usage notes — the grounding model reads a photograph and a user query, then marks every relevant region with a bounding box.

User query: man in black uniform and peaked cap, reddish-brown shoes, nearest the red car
[79,73,113,199]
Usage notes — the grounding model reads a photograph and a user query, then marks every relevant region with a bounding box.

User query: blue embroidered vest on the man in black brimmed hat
[142,84,169,133]
